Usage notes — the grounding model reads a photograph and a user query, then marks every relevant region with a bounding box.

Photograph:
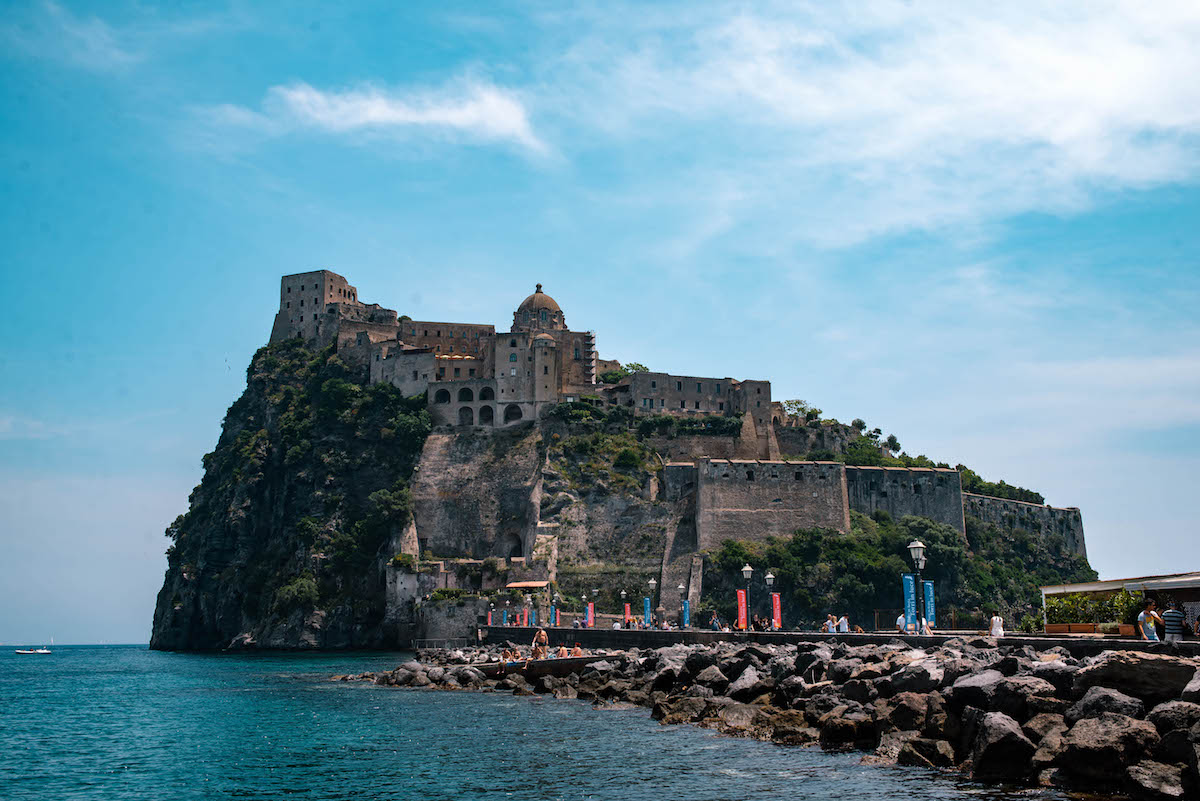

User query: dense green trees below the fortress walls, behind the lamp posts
[704,512,1096,631]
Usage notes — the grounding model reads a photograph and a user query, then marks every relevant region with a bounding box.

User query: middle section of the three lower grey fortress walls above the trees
[846,466,966,534]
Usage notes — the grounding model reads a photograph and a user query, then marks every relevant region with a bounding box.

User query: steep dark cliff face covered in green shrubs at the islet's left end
[150,339,430,650]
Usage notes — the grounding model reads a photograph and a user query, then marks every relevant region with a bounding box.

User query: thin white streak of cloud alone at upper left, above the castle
[204,80,550,156]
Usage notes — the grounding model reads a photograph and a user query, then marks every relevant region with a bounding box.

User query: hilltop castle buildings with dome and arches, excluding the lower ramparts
[271,270,782,459]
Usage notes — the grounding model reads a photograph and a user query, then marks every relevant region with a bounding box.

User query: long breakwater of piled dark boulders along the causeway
[335,638,1200,799]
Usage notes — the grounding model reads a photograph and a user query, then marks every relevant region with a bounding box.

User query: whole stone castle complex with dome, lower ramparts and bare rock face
[271,270,1086,623]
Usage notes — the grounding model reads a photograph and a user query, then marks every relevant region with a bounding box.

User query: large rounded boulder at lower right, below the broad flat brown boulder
[1058,712,1159,782]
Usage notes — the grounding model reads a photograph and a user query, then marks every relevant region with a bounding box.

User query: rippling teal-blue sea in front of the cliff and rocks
[0,645,1067,801]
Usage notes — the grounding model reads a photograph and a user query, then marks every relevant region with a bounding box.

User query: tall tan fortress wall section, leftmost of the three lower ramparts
[696,459,850,550]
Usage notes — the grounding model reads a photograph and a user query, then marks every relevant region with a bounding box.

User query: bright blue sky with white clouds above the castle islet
[0,0,1200,643]
